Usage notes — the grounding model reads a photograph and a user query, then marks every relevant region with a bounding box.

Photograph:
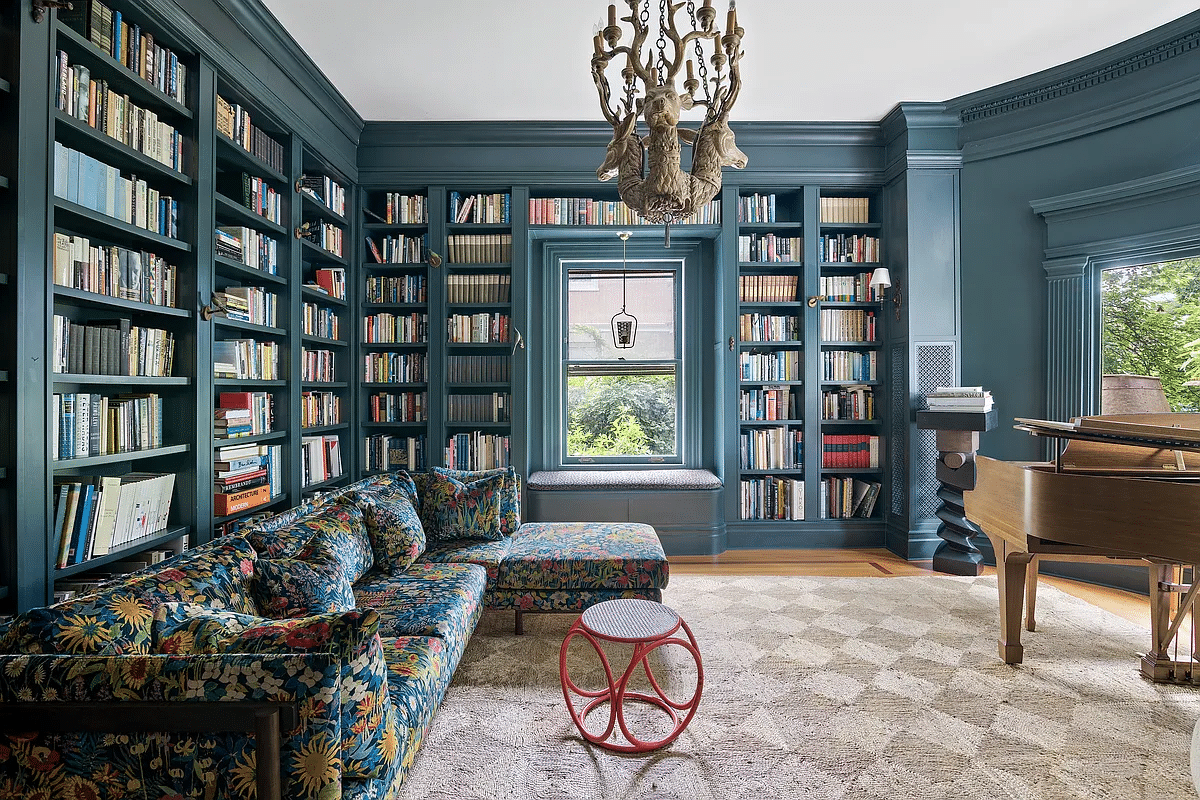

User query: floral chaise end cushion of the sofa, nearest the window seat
[496,522,668,589]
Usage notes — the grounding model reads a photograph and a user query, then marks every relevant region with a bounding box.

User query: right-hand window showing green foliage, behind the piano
[1100,258,1200,413]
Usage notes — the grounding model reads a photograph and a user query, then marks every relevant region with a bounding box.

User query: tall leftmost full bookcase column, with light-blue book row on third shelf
[44,2,198,600]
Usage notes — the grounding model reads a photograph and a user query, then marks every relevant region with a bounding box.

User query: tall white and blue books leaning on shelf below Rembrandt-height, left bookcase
[53,473,175,570]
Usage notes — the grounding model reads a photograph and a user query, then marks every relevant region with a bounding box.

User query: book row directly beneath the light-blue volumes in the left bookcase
[54,231,178,308]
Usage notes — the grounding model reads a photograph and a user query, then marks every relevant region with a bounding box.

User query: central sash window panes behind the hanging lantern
[560,261,683,464]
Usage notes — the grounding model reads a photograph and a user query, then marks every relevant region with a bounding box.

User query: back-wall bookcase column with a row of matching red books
[816,191,883,519]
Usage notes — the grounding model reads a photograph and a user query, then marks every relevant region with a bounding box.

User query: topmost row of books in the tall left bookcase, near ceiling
[58,0,187,106]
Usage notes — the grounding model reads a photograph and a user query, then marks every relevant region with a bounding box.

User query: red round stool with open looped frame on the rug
[558,600,704,753]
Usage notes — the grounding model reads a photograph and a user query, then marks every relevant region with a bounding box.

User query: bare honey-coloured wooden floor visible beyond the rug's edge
[671,549,1150,630]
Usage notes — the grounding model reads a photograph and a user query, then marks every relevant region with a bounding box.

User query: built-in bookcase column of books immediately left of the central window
[440,190,511,469]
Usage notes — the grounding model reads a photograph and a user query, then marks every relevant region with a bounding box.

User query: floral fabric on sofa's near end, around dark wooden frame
[0,652,342,800]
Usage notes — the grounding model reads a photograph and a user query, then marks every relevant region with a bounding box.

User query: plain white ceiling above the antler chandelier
[263,0,1196,121]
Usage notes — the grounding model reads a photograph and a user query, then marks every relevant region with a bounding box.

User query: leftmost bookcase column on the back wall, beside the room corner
[355,187,432,475]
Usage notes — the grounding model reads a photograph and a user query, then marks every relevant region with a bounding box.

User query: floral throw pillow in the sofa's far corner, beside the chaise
[421,467,521,541]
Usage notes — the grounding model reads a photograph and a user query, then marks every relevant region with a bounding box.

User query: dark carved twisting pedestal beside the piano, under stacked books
[917,409,997,575]
